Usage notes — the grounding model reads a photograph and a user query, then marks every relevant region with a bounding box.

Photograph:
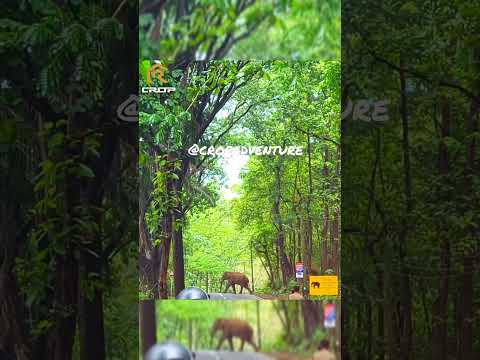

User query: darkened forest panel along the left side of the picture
[0,0,138,360]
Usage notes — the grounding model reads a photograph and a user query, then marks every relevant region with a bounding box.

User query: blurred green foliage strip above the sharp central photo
[140,0,340,60]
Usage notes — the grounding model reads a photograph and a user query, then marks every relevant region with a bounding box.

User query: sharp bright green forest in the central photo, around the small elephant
[139,60,341,298]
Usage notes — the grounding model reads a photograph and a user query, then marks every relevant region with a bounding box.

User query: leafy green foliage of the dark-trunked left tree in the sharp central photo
[140,61,268,296]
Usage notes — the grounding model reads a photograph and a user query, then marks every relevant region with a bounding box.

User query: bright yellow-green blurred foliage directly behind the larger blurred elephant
[156,300,325,355]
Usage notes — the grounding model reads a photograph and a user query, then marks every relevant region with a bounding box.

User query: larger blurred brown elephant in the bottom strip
[212,319,259,352]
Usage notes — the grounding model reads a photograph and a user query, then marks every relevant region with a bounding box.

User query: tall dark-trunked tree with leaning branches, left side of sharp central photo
[140,61,261,298]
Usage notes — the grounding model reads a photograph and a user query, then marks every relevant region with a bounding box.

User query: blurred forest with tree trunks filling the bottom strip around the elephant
[140,300,340,360]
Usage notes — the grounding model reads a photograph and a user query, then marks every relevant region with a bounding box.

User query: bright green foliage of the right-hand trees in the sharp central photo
[234,62,340,288]
